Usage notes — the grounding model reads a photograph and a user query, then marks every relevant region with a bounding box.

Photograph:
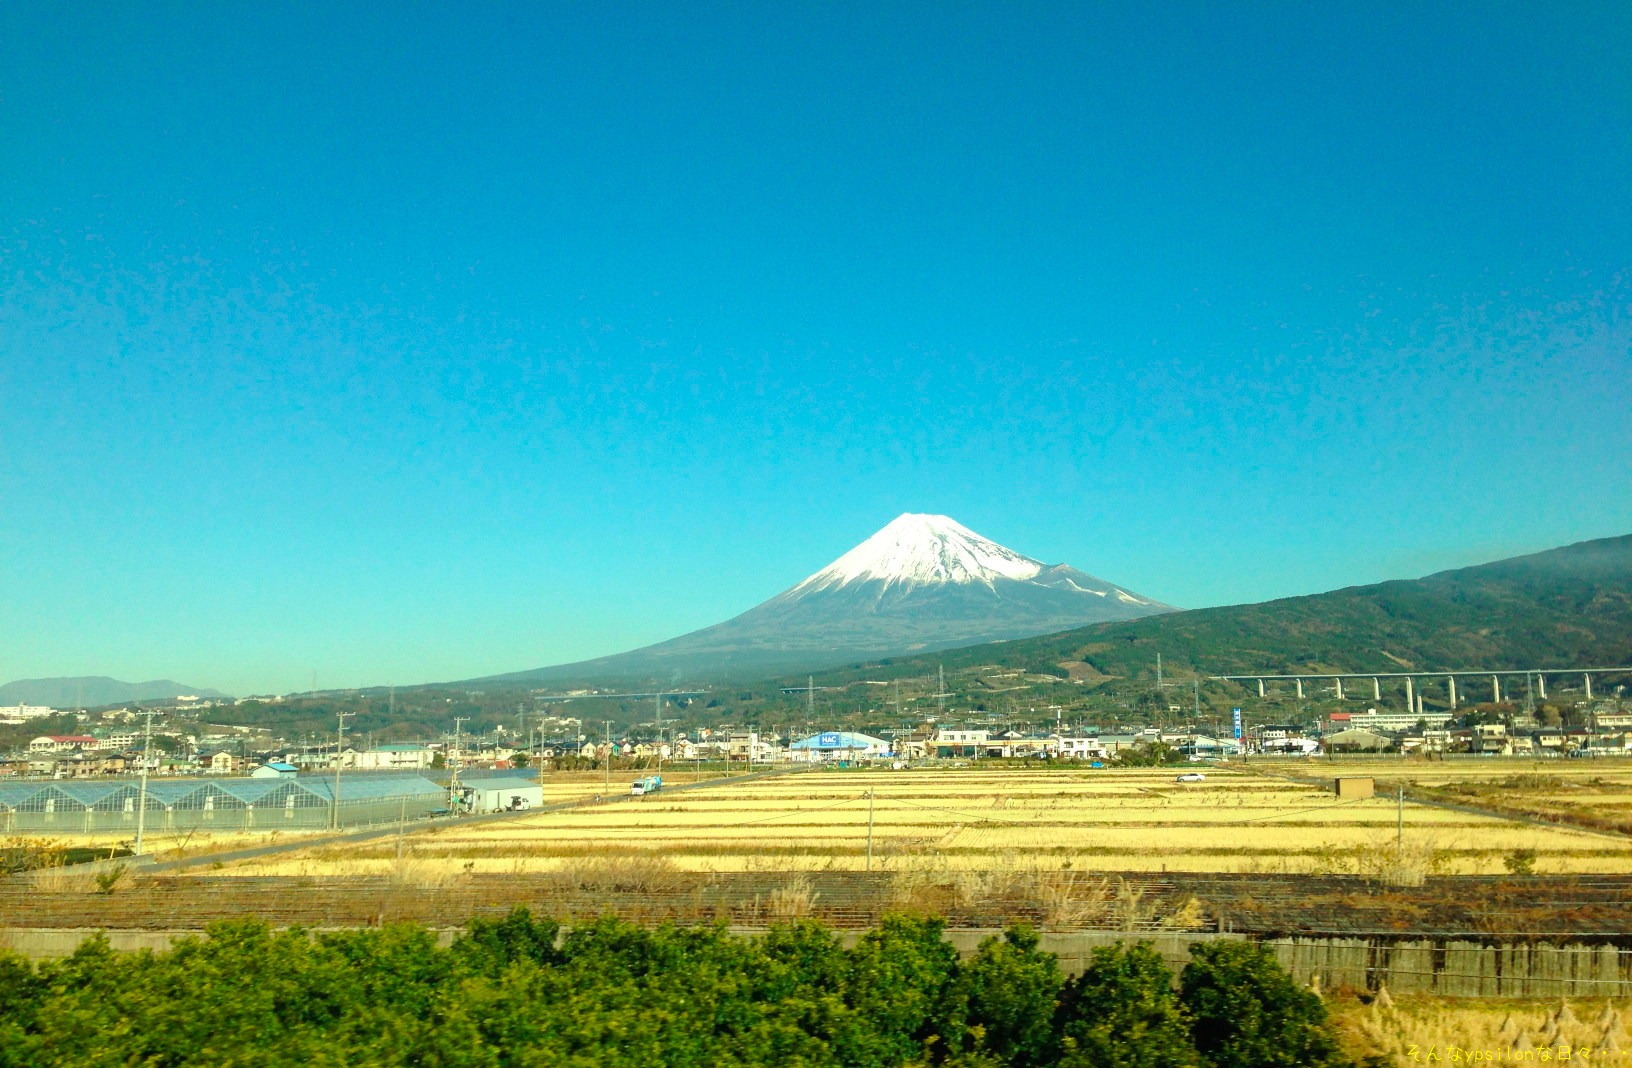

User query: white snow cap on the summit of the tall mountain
[793,513,1044,593]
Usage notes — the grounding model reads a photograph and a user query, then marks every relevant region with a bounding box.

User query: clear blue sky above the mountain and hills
[0,0,1632,692]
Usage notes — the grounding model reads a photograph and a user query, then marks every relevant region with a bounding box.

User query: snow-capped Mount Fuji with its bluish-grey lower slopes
[481,514,1177,683]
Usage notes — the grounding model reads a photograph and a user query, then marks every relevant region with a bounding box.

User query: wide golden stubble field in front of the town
[211,764,1632,880]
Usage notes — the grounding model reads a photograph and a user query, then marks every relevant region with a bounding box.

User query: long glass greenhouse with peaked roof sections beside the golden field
[0,776,447,834]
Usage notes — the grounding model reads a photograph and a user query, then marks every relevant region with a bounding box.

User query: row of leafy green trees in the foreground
[0,910,1343,1068]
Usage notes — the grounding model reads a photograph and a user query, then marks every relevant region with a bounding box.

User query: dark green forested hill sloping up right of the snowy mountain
[812,536,1632,678]
